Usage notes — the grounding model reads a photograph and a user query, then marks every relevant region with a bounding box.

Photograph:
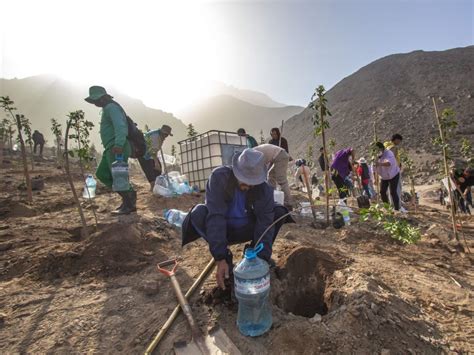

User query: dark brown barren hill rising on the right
[285,46,474,165]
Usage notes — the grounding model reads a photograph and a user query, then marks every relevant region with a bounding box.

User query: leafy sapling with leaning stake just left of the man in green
[64,110,97,238]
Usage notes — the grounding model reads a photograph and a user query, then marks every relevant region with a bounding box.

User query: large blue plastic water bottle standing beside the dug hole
[234,243,272,337]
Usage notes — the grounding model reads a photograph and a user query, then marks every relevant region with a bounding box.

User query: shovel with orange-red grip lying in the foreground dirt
[157,259,240,355]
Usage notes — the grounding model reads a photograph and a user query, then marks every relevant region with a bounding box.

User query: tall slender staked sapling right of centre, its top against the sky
[309,85,331,225]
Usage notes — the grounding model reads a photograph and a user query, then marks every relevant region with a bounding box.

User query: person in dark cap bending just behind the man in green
[138,125,173,191]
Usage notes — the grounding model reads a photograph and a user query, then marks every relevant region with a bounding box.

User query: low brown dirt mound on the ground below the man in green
[36,224,161,279]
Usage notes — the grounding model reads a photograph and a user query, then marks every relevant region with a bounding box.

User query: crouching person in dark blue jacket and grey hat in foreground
[182,148,294,289]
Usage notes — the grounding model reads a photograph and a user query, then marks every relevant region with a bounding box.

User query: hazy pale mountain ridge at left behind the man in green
[0,75,186,152]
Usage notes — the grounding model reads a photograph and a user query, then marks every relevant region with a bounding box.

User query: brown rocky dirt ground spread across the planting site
[0,156,474,354]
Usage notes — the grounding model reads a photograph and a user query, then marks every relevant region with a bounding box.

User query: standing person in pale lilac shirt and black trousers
[375,142,400,211]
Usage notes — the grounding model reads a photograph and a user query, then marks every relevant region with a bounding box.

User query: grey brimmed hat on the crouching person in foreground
[232,148,267,186]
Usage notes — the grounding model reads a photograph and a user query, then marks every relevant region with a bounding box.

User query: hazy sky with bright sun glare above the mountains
[0,0,474,111]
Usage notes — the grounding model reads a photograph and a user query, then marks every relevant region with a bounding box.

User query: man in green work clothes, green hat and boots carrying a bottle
[85,86,137,215]
